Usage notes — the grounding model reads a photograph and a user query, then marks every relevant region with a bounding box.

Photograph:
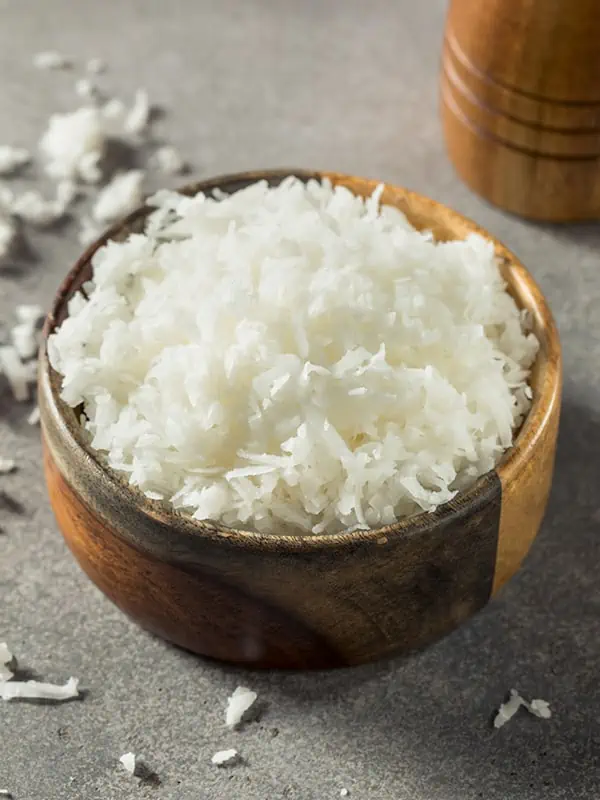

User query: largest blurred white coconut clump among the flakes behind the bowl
[40,106,106,183]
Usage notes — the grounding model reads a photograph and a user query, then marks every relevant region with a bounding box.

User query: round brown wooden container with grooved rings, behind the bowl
[441,0,600,222]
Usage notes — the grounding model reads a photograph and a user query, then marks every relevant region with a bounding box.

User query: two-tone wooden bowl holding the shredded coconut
[39,171,561,668]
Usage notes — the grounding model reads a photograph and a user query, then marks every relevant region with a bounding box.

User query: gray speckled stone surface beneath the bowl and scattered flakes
[0,0,600,800]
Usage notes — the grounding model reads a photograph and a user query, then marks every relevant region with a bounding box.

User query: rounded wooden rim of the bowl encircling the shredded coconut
[39,168,562,552]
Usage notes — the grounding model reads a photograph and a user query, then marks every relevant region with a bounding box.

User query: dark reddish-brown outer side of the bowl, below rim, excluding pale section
[45,438,500,669]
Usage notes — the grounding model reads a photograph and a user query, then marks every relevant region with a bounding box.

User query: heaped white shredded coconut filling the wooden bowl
[49,178,538,533]
